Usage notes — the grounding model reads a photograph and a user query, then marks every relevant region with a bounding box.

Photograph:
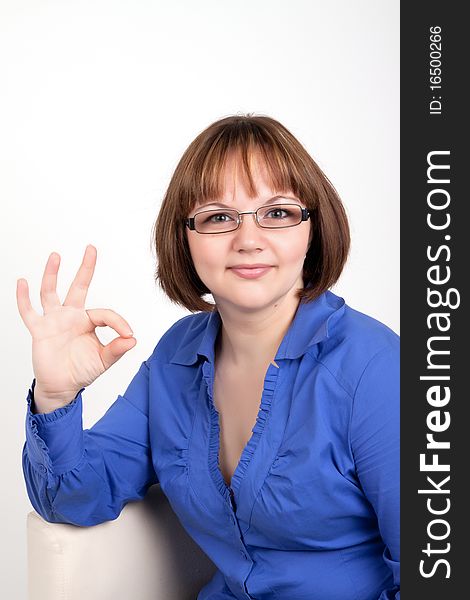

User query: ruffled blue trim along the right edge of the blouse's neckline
[231,363,280,491]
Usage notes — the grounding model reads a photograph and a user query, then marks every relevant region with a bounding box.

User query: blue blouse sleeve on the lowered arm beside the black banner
[350,337,400,600]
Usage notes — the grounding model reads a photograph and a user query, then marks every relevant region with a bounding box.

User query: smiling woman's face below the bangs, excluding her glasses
[186,152,311,311]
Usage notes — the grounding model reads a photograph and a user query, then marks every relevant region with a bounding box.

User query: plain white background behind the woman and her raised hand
[0,0,399,600]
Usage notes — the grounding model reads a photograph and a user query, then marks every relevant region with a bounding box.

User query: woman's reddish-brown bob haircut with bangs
[152,113,350,312]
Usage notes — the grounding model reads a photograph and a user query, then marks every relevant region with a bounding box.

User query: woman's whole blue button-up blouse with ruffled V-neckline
[23,291,400,600]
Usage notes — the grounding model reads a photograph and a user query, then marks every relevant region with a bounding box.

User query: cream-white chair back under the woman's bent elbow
[27,485,216,600]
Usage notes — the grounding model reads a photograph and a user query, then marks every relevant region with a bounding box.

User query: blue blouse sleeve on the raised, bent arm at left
[22,362,158,526]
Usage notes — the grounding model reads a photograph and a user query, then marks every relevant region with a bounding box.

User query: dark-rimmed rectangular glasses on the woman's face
[184,204,310,234]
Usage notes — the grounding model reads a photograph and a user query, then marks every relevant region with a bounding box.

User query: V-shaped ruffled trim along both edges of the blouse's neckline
[202,362,279,502]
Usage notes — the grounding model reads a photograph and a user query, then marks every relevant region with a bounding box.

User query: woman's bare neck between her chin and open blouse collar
[215,287,299,370]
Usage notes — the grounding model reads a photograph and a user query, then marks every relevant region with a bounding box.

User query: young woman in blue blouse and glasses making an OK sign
[17,115,399,600]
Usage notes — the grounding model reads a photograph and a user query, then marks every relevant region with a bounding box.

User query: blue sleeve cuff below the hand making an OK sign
[26,379,85,476]
